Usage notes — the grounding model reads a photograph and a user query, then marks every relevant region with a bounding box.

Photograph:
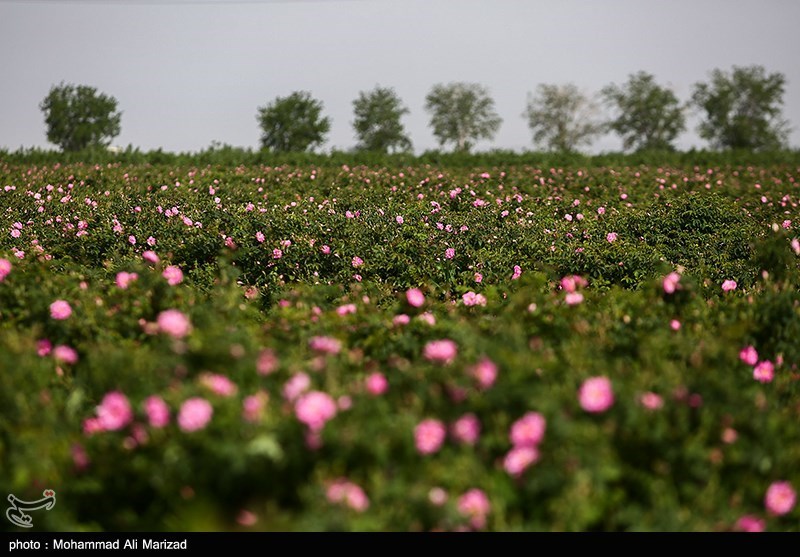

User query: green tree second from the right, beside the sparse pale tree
[602,72,686,151]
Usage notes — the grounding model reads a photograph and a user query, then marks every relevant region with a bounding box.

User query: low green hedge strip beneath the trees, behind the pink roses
[0,144,800,168]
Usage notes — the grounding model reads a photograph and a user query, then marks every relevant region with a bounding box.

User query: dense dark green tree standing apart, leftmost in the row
[39,82,122,151]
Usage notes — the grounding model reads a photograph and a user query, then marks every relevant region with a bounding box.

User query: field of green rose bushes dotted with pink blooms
[0,157,800,532]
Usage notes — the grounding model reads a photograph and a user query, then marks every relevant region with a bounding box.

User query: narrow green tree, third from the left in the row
[353,87,411,153]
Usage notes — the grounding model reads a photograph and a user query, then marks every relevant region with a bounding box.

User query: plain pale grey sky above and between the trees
[0,0,800,153]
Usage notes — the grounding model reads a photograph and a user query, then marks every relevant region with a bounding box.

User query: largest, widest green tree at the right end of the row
[692,66,789,151]
